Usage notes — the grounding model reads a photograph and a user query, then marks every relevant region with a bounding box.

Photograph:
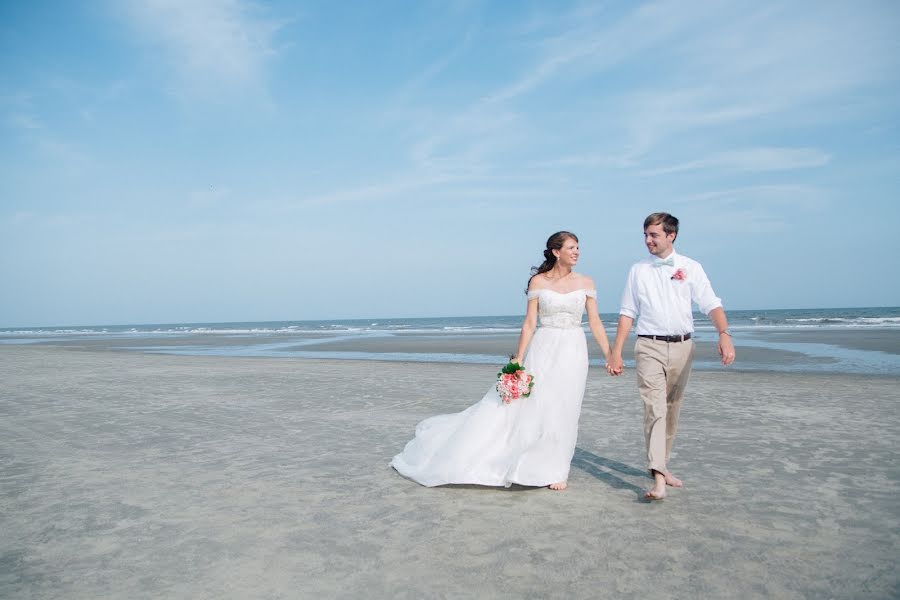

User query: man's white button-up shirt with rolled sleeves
[619,250,722,335]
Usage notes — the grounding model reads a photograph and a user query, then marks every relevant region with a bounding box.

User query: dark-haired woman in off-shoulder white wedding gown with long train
[391,231,609,490]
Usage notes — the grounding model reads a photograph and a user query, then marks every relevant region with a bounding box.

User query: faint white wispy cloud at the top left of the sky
[126,0,283,91]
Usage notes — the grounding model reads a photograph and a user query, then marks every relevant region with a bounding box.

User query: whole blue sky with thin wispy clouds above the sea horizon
[0,0,900,326]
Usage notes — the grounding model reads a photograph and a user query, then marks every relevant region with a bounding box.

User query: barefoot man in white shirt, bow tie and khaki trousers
[606,213,734,500]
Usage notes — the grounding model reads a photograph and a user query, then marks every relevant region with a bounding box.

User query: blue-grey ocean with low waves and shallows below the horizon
[0,307,900,375]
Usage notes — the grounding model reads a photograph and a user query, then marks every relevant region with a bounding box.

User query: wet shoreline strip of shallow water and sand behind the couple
[0,328,900,375]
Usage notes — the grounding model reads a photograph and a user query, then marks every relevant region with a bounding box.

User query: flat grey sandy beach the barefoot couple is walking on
[0,345,900,599]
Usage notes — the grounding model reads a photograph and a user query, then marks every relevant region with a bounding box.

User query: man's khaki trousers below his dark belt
[634,337,694,473]
